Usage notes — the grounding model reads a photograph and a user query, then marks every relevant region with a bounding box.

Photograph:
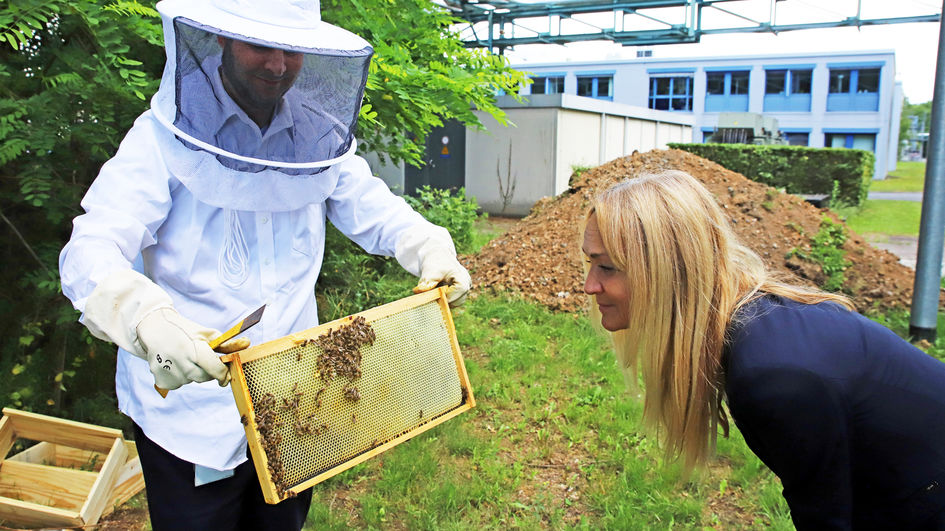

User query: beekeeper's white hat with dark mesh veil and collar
[151,0,373,210]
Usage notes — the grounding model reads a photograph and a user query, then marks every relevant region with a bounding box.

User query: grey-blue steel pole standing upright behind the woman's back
[909,2,945,341]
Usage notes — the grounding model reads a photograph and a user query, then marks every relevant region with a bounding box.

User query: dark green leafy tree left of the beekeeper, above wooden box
[0,0,164,421]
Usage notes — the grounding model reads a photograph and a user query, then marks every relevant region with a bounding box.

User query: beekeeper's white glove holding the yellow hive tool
[83,269,242,389]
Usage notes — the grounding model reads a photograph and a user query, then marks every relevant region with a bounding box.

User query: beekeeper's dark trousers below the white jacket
[135,425,312,531]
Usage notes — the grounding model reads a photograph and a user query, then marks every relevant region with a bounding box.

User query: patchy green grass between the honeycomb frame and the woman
[306,294,792,530]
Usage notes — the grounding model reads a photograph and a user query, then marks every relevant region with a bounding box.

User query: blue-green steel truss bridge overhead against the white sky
[442,0,941,53]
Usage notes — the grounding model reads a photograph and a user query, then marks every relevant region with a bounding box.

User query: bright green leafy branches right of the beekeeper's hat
[322,0,526,166]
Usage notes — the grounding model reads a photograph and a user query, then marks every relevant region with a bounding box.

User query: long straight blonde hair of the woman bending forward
[587,170,853,471]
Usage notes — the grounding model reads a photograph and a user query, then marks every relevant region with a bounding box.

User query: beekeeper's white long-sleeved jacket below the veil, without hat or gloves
[60,111,453,470]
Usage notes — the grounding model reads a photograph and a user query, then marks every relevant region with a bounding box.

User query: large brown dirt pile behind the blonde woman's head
[462,150,914,311]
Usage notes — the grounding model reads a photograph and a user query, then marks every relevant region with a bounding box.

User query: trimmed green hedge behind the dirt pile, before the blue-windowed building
[669,143,876,205]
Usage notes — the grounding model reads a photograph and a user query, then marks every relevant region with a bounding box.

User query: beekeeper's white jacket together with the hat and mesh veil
[59,0,455,472]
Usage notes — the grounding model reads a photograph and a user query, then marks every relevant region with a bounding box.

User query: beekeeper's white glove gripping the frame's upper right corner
[395,229,472,307]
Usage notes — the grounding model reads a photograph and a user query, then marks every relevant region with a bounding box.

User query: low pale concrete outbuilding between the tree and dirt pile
[466,94,692,216]
